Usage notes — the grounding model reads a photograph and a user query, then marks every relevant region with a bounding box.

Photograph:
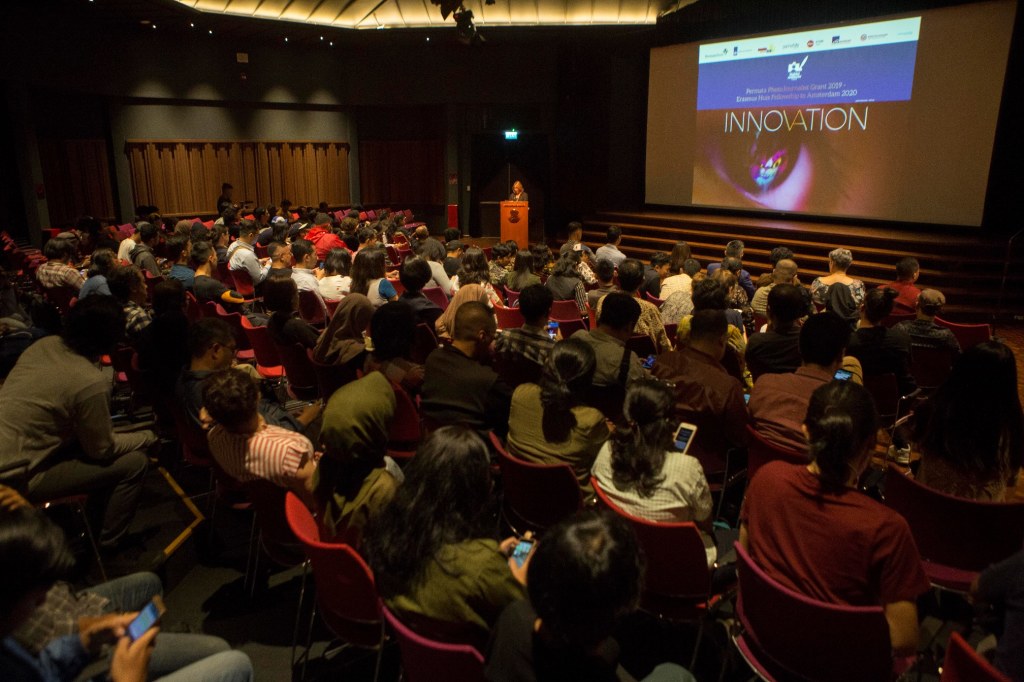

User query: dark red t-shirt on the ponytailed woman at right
[740,462,929,606]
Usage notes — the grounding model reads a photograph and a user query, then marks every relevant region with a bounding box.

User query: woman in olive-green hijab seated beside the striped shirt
[313,372,402,546]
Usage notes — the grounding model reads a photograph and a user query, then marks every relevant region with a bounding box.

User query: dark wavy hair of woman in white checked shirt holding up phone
[611,379,675,498]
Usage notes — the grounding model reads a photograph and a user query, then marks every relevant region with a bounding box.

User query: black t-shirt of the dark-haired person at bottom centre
[483,601,618,682]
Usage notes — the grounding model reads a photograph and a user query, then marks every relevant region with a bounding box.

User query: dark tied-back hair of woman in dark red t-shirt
[804,381,879,492]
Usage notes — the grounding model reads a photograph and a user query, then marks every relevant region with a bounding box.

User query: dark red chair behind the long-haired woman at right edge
[884,467,1024,592]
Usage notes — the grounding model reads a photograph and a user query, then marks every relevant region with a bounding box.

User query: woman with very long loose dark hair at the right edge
[910,341,1024,502]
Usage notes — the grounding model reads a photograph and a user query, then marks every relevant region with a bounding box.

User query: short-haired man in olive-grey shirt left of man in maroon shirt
[572,293,647,391]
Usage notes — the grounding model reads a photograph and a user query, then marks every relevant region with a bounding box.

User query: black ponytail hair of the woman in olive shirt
[541,339,597,442]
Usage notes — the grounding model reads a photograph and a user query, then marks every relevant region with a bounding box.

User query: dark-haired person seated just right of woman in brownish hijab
[366,300,423,393]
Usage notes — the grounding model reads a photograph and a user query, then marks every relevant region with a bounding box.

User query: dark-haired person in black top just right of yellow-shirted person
[745,280,807,381]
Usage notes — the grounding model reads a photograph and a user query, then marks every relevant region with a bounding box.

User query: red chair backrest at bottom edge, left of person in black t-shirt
[381,604,483,682]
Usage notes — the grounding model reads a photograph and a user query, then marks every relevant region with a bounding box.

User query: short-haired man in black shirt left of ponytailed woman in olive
[421,301,512,437]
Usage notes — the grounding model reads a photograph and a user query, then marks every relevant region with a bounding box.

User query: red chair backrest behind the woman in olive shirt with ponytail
[490,433,583,532]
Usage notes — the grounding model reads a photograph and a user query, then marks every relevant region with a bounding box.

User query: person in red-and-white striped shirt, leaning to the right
[197,370,319,509]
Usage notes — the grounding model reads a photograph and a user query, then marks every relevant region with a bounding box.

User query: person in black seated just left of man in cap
[846,287,918,395]
